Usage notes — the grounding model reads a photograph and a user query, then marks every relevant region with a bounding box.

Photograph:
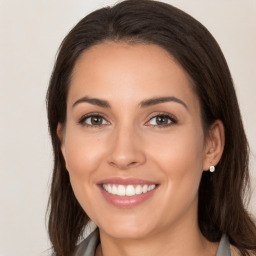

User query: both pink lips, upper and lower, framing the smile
[97,178,158,208]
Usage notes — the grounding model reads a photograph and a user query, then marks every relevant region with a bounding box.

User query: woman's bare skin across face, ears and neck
[57,42,224,256]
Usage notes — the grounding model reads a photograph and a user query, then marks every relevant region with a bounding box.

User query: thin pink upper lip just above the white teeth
[97,177,157,185]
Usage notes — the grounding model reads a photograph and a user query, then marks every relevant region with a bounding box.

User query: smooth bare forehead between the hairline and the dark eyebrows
[68,42,197,110]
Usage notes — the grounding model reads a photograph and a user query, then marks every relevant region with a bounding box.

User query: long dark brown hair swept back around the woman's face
[47,0,256,256]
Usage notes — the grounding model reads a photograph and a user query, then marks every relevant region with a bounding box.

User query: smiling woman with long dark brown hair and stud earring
[47,0,256,256]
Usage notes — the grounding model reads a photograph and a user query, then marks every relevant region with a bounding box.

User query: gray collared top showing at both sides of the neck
[75,229,231,256]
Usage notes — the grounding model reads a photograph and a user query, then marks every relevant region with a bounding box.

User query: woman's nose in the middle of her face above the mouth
[108,128,146,170]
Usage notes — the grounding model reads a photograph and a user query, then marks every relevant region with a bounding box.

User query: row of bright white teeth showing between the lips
[102,184,156,196]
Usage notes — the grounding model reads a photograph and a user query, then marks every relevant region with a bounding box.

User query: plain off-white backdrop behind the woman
[0,0,256,256]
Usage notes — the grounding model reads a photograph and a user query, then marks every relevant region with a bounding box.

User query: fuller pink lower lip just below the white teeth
[99,186,157,208]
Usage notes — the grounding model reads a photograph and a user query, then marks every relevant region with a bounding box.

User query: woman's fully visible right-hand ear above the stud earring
[203,120,225,171]
